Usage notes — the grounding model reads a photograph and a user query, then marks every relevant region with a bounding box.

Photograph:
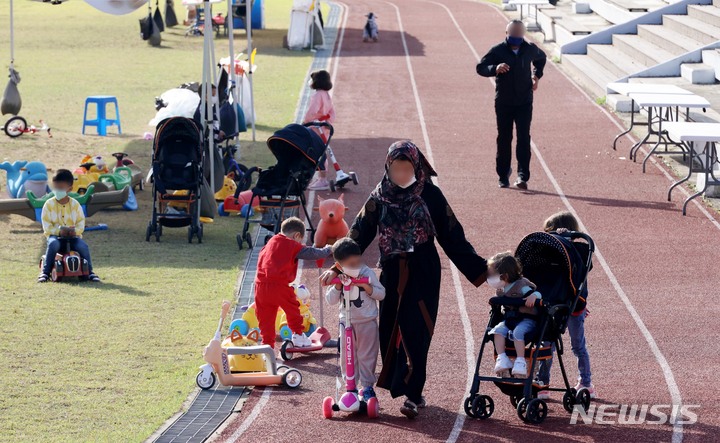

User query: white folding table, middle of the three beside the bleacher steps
[629,93,710,173]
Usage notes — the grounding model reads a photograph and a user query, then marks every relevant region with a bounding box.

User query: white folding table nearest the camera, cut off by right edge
[665,122,720,215]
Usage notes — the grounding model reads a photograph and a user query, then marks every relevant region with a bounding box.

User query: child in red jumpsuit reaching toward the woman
[255,217,332,348]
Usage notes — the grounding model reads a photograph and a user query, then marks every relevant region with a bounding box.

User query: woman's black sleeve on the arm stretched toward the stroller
[423,184,487,286]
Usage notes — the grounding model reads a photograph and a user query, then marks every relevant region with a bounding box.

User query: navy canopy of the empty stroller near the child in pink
[267,123,325,171]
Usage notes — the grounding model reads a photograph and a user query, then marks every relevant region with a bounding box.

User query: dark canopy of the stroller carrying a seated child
[515,232,586,306]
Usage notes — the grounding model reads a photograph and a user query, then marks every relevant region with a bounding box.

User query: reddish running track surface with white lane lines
[219,0,720,442]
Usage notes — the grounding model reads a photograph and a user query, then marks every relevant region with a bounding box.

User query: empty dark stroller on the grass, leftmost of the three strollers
[145,117,203,243]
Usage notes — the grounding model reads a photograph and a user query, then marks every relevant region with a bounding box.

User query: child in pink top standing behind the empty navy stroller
[303,70,335,191]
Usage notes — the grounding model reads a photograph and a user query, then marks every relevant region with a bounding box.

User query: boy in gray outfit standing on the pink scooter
[325,238,385,401]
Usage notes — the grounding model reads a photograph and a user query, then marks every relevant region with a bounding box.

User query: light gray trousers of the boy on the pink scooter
[340,320,380,388]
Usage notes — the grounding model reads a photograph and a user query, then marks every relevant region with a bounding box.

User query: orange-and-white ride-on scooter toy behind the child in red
[195,301,302,389]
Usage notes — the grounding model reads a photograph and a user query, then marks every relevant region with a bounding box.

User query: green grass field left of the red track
[0,0,318,442]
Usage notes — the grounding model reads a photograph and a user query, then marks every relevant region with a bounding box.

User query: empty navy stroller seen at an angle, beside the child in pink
[235,122,333,249]
